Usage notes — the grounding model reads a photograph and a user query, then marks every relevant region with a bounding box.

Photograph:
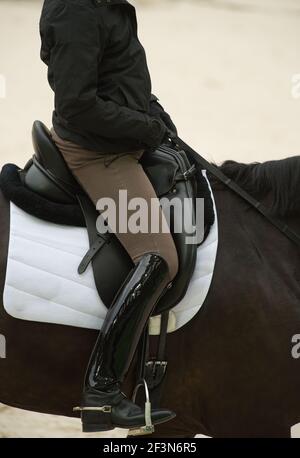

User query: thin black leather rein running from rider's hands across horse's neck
[171,137,300,247]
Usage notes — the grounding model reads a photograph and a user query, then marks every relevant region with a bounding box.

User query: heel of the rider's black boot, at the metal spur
[74,406,115,433]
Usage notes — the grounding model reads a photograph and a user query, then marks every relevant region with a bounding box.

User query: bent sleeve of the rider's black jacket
[41,2,166,146]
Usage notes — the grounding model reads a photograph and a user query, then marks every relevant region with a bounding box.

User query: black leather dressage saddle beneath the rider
[21,121,197,315]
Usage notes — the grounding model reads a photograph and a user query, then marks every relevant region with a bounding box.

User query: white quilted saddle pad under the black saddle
[4,174,218,334]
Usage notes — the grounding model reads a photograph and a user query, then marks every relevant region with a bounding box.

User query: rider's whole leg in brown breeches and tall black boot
[54,128,178,431]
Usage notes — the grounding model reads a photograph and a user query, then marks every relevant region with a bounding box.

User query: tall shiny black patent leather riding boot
[74,254,175,432]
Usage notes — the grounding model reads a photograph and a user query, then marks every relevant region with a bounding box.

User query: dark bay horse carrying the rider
[0,157,300,437]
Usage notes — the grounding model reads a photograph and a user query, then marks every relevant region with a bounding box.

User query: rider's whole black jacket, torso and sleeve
[40,0,166,152]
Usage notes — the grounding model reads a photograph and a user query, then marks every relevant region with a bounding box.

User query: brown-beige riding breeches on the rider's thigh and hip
[51,128,178,281]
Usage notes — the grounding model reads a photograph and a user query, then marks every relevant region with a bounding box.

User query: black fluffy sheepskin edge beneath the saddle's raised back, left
[0,164,85,227]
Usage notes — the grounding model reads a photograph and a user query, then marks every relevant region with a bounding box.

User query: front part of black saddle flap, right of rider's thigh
[141,145,197,315]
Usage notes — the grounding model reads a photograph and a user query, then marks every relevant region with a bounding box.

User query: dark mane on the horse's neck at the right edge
[220,156,300,216]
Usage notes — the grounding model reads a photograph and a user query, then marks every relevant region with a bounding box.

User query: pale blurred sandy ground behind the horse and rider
[0,0,300,437]
